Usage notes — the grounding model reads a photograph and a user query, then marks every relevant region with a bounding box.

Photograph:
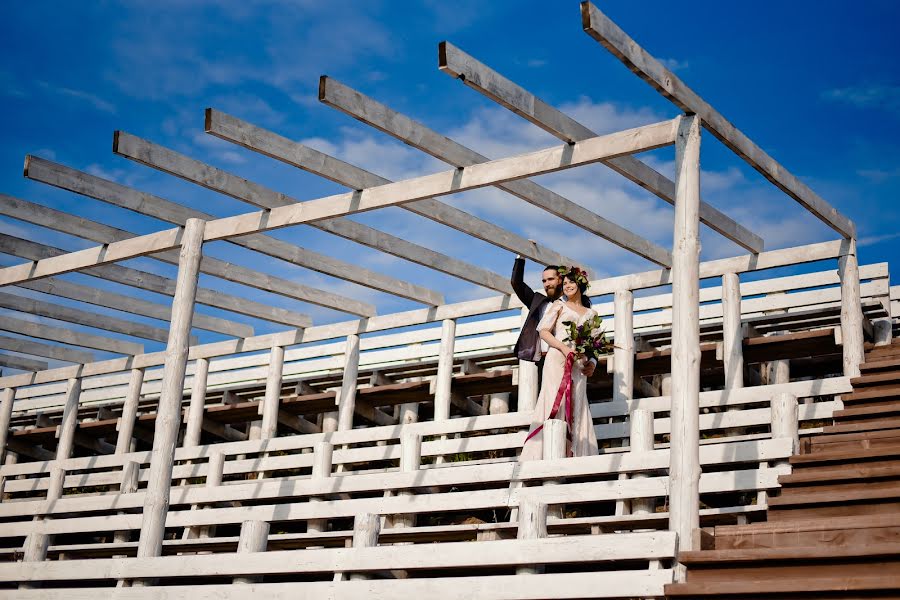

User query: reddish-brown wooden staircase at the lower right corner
[666,339,900,599]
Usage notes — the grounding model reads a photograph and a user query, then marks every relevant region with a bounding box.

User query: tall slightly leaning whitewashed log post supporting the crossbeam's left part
[137,219,206,558]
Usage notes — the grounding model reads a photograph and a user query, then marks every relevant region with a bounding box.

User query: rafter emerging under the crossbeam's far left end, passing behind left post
[19,277,253,338]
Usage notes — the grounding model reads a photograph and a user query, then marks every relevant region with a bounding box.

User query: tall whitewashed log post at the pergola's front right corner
[669,115,700,568]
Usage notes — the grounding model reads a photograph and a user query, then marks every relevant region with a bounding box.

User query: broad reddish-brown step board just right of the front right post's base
[714,513,900,550]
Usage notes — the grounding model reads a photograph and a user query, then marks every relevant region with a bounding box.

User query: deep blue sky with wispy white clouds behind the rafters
[0,0,900,360]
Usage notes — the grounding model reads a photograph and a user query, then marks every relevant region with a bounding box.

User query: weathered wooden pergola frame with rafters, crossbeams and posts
[0,2,863,576]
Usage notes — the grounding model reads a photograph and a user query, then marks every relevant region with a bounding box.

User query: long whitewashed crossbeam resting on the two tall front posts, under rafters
[0,119,677,286]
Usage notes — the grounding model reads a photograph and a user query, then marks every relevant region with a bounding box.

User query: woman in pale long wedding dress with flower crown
[519,267,597,461]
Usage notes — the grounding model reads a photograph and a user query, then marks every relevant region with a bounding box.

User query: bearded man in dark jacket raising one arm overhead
[509,255,597,377]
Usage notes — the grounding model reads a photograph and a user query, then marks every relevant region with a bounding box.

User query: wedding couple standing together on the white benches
[510,256,598,461]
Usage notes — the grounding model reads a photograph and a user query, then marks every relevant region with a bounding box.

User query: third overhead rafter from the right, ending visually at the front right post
[319,76,672,267]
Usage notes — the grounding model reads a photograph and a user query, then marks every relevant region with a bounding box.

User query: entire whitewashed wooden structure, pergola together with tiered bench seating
[0,2,884,598]
